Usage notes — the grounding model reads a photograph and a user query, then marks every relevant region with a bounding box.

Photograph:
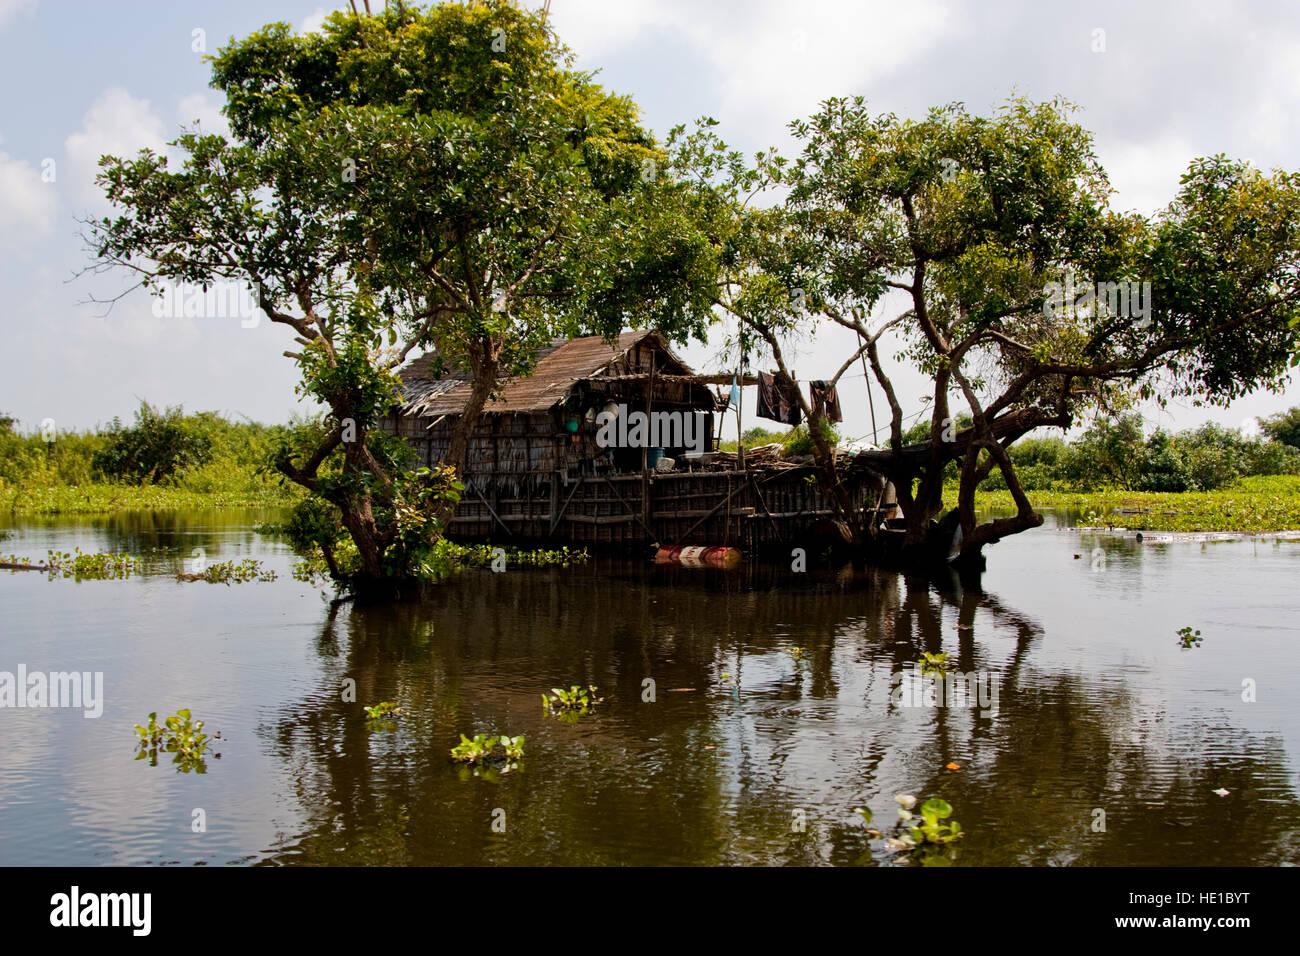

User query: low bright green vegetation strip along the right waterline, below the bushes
[967,475,1300,532]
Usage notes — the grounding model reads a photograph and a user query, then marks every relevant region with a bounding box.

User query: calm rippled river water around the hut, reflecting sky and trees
[0,511,1300,866]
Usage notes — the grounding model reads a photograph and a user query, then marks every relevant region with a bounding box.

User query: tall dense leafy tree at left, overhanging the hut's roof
[88,0,716,584]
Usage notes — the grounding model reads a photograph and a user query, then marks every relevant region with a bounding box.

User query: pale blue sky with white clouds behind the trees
[0,0,1300,437]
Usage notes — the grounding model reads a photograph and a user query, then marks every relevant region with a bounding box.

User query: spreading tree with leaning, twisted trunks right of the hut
[673,98,1300,558]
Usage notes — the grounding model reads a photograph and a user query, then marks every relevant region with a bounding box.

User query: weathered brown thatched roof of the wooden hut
[398,332,694,418]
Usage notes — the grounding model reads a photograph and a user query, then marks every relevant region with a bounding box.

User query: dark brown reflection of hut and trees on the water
[258,554,1300,865]
